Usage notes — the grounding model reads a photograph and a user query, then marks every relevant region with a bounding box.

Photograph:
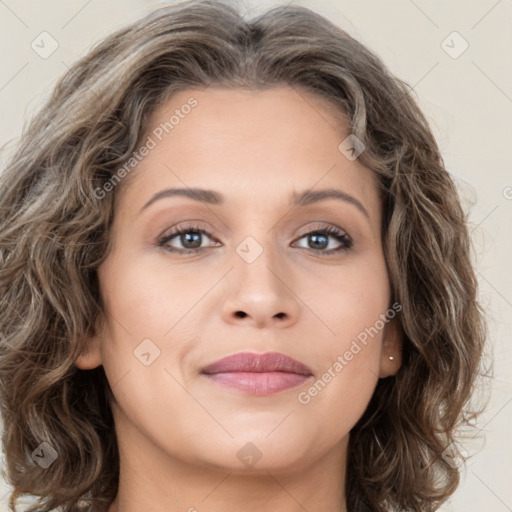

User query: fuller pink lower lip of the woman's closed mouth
[202,372,312,395]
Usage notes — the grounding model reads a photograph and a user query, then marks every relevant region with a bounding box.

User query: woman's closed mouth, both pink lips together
[201,352,313,396]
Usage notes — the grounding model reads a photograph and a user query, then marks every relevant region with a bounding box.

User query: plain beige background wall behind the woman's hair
[0,0,512,512]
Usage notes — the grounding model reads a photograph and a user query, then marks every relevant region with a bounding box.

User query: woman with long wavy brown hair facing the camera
[0,2,485,512]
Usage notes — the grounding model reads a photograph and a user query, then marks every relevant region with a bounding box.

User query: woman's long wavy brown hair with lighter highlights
[0,1,486,512]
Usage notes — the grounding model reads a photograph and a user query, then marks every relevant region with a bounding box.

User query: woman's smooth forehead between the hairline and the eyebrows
[118,86,378,224]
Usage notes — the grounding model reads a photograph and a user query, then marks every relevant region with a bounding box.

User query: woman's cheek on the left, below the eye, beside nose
[98,250,213,396]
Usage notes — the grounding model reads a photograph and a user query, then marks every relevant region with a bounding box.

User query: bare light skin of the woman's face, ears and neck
[76,86,401,512]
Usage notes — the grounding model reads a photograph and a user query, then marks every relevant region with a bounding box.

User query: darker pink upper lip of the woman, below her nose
[201,352,313,376]
